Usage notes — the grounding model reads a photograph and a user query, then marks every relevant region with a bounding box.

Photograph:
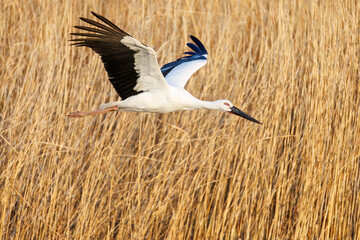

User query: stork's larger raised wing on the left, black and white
[70,12,168,100]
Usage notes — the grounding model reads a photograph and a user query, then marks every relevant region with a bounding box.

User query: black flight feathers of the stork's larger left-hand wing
[70,12,141,100]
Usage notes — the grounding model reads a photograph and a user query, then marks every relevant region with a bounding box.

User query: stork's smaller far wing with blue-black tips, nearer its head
[161,36,207,88]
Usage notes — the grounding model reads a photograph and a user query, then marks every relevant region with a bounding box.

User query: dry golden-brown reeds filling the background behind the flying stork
[0,0,360,239]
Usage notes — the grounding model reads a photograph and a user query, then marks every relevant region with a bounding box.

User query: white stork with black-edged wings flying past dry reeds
[68,12,261,124]
